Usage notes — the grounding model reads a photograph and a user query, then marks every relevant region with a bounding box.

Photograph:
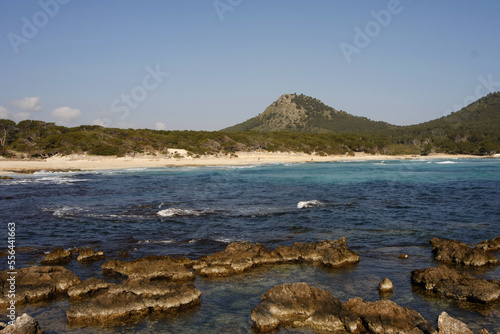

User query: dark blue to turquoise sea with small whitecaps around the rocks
[0,157,500,334]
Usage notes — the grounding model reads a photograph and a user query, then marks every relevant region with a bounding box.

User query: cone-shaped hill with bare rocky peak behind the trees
[221,94,395,133]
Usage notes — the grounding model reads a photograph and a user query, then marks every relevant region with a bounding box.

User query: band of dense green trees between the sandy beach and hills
[0,120,500,157]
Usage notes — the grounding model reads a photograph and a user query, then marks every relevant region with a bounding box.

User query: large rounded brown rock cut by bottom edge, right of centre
[251,283,436,334]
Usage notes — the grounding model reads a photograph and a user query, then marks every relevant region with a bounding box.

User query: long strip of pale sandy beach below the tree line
[0,152,494,175]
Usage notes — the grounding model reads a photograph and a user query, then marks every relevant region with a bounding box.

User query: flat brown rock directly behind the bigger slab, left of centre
[101,255,195,281]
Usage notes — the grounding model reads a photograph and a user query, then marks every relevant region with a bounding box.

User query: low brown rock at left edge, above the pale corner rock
[0,266,82,307]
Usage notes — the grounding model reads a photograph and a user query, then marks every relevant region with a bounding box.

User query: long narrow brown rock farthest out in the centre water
[193,238,359,277]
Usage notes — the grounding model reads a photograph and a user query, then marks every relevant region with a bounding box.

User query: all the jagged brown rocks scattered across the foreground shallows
[0,238,500,334]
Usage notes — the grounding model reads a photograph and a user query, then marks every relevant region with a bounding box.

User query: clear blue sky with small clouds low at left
[0,0,500,131]
